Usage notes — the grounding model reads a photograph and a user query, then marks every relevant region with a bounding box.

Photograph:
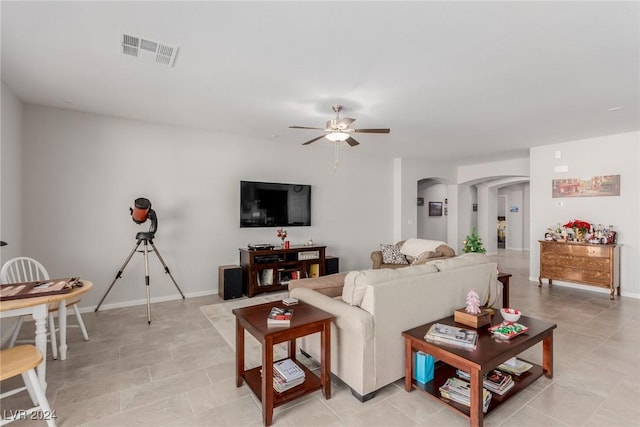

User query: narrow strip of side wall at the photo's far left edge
[0,82,23,265]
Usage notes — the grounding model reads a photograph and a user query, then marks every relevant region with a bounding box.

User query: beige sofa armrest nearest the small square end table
[290,288,374,340]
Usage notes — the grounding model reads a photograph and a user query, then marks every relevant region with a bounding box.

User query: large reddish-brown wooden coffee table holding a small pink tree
[402,312,556,426]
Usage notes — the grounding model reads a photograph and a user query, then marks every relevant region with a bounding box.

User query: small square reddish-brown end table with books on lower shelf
[232,301,334,426]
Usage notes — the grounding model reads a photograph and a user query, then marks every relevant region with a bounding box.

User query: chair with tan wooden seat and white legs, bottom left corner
[0,345,56,427]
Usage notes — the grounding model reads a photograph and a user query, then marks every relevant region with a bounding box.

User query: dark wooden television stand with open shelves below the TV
[239,246,327,297]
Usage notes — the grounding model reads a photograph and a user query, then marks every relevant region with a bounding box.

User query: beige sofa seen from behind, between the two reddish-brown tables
[289,254,502,401]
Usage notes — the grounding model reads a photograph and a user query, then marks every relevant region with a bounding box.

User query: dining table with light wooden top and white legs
[0,279,93,390]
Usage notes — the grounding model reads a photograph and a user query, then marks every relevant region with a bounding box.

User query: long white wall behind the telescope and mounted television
[20,105,396,308]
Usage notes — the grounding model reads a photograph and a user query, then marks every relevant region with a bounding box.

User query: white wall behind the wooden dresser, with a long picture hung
[530,132,640,297]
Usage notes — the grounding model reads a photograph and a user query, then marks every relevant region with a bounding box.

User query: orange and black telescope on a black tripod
[94,197,184,324]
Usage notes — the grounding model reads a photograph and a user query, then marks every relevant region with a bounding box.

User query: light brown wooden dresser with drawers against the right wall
[538,240,620,299]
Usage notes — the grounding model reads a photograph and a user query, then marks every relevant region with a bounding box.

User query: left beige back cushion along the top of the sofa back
[342,264,438,307]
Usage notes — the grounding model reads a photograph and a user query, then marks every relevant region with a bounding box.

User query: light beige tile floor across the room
[0,250,640,427]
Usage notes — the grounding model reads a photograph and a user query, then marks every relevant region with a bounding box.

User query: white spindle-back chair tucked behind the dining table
[0,257,89,359]
